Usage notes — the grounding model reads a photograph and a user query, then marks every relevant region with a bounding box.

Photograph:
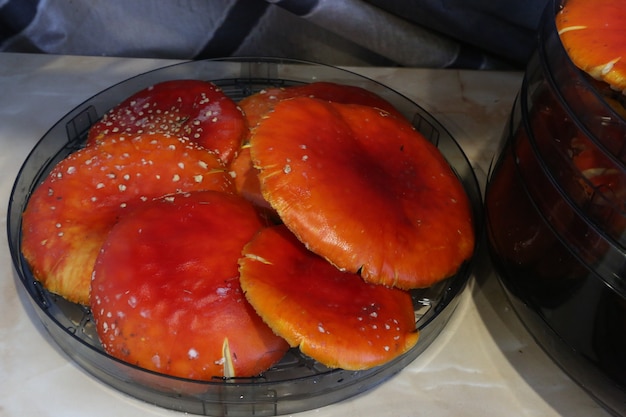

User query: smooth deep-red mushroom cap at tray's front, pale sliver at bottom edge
[91,191,289,380]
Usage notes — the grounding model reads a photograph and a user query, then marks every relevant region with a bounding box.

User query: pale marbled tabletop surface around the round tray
[0,53,608,417]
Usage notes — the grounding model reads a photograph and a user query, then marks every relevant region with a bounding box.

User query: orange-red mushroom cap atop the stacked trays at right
[556,0,626,92]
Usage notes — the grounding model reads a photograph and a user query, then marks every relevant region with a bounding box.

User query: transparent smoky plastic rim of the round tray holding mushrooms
[7,57,483,416]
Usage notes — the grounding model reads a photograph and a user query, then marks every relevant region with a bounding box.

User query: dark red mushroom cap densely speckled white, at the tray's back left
[87,79,248,164]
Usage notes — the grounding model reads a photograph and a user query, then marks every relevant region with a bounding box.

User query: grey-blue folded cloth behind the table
[0,0,548,69]
